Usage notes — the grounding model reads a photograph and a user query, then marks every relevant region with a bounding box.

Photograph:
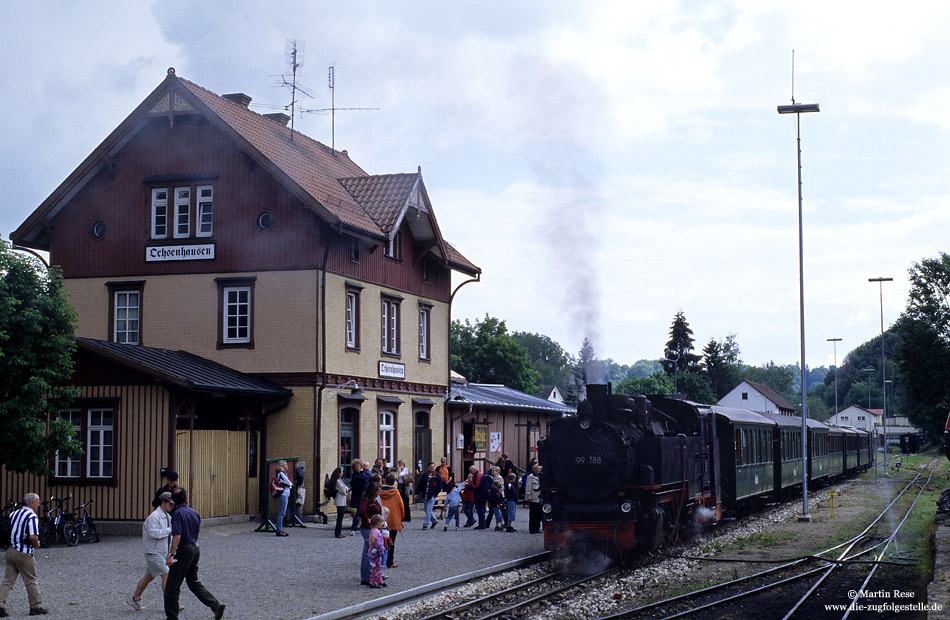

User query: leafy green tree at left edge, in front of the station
[0,241,81,476]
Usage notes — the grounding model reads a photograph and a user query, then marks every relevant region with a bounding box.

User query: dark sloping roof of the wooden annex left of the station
[76,338,292,398]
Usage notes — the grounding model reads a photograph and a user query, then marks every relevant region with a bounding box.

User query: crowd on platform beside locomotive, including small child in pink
[324,455,543,588]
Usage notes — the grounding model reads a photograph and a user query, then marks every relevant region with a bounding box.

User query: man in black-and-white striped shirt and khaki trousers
[0,493,49,618]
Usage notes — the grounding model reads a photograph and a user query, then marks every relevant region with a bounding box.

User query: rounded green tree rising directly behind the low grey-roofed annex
[449,314,541,394]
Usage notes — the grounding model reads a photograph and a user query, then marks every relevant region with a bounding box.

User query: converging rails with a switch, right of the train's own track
[598,459,936,620]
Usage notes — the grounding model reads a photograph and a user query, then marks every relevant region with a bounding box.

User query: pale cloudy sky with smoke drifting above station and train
[0,0,950,366]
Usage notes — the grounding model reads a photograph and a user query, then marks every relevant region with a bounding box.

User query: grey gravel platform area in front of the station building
[0,510,543,620]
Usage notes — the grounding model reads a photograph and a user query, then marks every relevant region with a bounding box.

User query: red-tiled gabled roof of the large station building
[10,69,481,275]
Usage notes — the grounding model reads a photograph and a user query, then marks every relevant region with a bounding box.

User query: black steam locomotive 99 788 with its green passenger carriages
[538,384,874,558]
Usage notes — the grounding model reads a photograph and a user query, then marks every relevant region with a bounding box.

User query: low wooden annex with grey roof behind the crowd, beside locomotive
[445,373,575,472]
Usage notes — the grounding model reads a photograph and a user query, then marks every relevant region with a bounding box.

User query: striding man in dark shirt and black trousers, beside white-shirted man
[165,487,224,620]
